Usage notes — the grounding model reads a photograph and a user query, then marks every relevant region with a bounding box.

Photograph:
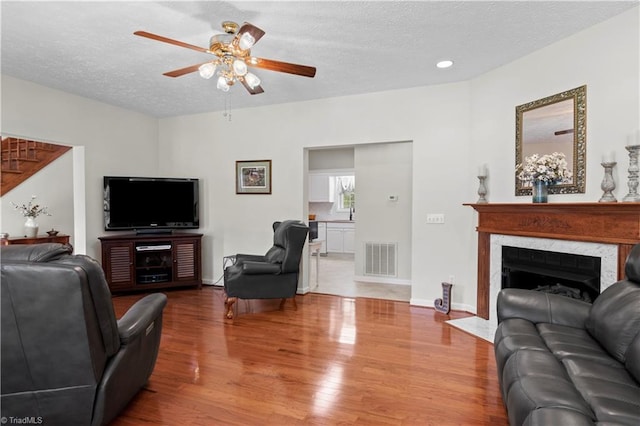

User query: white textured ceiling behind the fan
[1,0,638,117]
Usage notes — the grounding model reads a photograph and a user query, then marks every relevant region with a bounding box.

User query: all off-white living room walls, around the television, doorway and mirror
[2,8,640,311]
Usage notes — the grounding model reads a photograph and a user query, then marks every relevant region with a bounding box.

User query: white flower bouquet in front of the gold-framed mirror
[516,152,573,184]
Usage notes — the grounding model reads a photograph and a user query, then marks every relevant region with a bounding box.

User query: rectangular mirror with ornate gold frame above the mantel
[515,86,587,196]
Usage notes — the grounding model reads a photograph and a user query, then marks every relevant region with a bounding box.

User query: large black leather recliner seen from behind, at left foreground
[0,244,167,425]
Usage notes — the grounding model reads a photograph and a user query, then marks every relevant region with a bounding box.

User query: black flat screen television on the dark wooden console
[103,176,200,233]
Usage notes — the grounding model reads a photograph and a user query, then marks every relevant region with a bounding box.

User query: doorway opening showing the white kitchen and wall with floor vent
[305,142,413,301]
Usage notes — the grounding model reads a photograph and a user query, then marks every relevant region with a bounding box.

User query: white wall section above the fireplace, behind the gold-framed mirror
[469,7,640,202]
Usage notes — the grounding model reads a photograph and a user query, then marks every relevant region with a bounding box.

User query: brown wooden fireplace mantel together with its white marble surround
[465,203,640,320]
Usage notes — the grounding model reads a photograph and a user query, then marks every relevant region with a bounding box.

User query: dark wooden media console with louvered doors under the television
[99,233,202,293]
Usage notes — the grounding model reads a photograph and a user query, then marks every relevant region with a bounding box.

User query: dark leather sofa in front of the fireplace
[494,244,640,426]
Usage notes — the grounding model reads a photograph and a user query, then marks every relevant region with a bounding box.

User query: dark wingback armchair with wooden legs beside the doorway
[224,220,309,318]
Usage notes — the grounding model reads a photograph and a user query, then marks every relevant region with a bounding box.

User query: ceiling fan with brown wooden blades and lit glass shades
[134,21,316,95]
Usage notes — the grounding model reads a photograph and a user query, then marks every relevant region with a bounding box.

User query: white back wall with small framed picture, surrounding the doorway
[160,83,473,298]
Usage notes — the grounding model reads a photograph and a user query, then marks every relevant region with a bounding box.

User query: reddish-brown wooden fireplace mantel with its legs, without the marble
[465,203,640,319]
